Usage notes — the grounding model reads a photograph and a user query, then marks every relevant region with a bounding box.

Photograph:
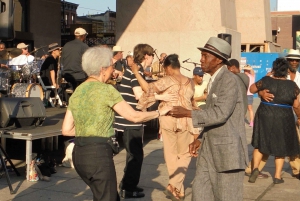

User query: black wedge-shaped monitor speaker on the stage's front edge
[0,97,46,128]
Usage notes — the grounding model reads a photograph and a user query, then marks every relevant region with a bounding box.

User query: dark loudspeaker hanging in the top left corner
[0,0,14,39]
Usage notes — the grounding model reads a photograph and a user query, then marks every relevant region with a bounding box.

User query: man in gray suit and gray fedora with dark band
[169,37,248,201]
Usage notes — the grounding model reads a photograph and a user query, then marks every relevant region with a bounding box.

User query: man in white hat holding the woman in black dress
[258,49,300,179]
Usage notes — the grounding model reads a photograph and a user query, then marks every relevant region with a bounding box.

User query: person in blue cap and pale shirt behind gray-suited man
[193,67,207,108]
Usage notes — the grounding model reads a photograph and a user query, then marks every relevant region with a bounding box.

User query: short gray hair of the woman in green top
[82,46,112,76]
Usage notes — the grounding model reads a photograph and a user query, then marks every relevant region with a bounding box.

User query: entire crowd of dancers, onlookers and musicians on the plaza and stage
[0,28,300,201]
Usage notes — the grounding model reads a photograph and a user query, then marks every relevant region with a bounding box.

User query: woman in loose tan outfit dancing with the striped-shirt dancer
[132,54,200,200]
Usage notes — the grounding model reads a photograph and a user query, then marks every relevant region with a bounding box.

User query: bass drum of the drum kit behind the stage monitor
[11,83,44,101]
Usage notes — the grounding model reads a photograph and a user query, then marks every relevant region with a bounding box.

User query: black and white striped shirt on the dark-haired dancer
[114,66,144,132]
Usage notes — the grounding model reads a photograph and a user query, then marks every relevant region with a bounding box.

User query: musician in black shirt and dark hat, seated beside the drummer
[40,43,61,88]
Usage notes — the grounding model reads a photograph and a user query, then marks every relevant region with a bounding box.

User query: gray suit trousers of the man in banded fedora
[192,139,244,201]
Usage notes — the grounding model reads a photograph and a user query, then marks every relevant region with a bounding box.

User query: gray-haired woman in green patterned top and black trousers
[62,47,171,201]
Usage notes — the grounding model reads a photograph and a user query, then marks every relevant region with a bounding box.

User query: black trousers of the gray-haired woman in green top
[72,143,120,201]
